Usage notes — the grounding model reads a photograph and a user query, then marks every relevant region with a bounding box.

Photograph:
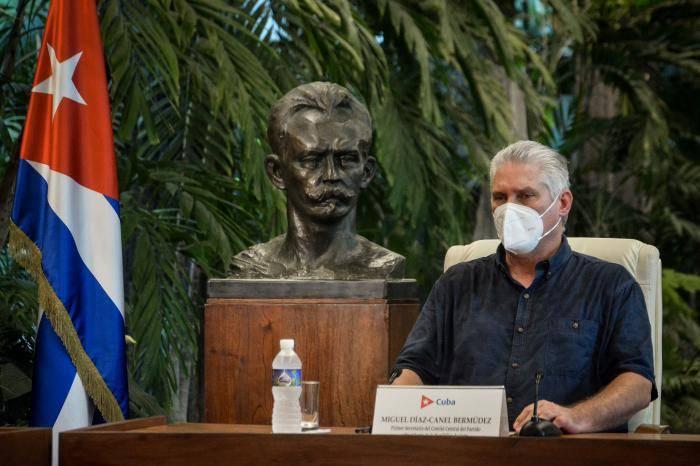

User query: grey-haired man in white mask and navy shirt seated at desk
[392,141,658,433]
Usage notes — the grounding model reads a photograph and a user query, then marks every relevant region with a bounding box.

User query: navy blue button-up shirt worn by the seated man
[396,237,658,431]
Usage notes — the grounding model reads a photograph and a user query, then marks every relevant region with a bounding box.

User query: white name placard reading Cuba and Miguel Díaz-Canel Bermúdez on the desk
[372,385,508,437]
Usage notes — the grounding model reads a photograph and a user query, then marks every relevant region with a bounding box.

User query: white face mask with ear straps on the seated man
[493,195,561,254]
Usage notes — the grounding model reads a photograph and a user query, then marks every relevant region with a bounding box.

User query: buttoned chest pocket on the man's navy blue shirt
[545,319,598,378]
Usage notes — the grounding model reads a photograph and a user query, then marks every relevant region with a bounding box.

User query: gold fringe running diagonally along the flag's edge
[9,222,124,422]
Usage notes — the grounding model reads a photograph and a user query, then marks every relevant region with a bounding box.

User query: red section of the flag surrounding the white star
[21,0,119,199]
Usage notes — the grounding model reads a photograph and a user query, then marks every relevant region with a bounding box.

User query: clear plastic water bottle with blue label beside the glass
[272,340,301,433]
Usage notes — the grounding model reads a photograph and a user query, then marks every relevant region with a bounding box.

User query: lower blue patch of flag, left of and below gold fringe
[31,315,75,427]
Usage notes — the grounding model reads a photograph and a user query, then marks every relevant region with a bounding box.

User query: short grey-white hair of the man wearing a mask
[489,141,570,198]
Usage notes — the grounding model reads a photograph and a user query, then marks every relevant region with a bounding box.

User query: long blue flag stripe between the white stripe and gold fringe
[12,160,128,416]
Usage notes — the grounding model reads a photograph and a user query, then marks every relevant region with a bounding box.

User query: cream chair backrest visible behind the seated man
[444,238,663,432]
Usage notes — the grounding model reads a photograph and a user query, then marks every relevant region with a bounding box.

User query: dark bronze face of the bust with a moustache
[281,108,375,222]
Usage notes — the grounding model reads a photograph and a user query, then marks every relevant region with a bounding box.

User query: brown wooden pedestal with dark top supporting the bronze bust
[204,280,419,426]
